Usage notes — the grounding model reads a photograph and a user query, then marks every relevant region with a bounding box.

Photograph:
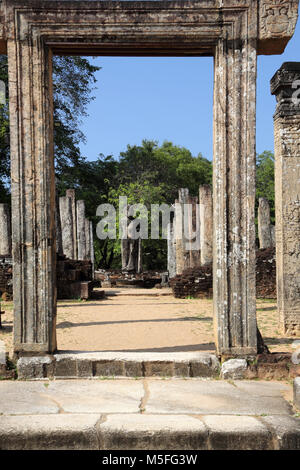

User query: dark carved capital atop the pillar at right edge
[271,62,300,116]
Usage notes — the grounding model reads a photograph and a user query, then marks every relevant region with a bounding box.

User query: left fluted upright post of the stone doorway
[7,39,56,354]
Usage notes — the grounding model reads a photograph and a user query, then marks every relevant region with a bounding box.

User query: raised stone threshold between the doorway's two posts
[17,352,220,379]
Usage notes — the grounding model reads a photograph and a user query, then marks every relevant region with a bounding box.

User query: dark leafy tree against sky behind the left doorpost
[0,55,100,201]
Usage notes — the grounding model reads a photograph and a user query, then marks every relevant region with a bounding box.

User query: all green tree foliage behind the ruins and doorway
[0,52,275,269]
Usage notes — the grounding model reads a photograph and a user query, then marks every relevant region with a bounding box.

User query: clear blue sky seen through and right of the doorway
[81,16,300,160]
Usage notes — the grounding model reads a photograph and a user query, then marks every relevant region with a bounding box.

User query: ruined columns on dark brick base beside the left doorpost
[0,190,97,300]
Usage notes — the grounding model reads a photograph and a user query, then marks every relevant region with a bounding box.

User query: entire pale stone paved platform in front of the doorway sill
[0,378,300,450]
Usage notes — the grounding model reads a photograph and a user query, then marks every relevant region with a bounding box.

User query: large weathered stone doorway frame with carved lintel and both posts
[0,0,298,356]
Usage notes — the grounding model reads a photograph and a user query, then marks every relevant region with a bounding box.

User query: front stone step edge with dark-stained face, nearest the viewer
[0,414,300,450]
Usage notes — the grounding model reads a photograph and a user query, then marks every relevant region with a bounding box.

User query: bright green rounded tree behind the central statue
[108,140,212,270]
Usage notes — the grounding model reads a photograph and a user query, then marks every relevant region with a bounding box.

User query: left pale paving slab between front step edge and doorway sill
[0,380,144,415]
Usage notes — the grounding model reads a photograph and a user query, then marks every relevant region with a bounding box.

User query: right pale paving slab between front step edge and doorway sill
[145,379,291,415]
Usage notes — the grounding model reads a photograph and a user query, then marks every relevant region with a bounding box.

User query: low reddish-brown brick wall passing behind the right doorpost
[170,248,276,299]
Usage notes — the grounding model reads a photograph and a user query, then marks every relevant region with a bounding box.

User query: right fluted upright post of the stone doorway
[213,37,257,356]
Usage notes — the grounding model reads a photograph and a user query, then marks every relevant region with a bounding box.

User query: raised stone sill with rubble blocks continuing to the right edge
[17,351,300,380]
